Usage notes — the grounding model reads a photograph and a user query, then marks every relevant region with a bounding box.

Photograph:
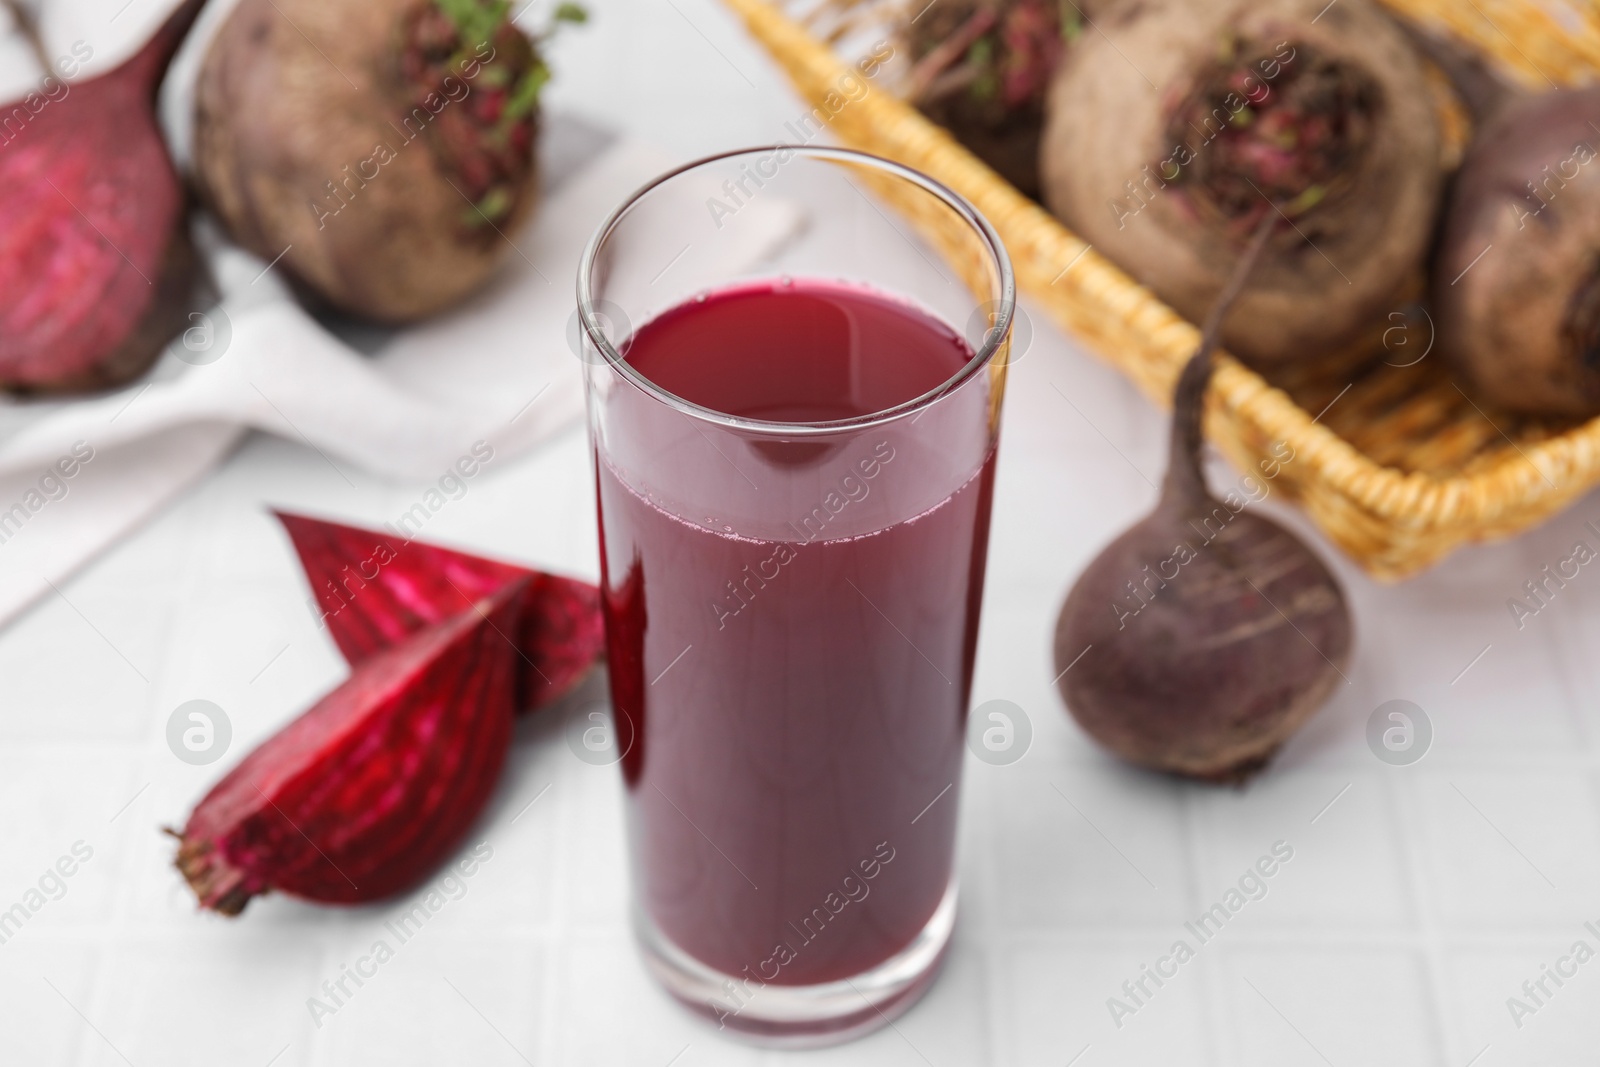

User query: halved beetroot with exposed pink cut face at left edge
[0,0,203,392]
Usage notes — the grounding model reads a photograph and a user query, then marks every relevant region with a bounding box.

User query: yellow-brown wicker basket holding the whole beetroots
[725,0,1600,579]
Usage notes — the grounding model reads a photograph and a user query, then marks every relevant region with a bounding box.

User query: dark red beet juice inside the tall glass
[595,278,995,992]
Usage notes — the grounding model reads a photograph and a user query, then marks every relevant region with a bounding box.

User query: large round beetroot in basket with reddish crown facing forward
[1040,0,1442,365]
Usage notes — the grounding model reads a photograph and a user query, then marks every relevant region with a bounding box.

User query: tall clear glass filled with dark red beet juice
[578,147,1014,1046]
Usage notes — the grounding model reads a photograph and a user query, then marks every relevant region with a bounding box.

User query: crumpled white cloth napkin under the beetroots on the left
[0,0,800,625]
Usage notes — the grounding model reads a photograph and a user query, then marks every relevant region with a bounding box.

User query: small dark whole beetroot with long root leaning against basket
[1054,218,1352,782]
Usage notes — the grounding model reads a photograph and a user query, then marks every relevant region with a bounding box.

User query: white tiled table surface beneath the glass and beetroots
[0,0,1600,1067]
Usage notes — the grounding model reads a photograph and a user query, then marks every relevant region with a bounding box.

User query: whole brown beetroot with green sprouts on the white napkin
[195,0,582,323]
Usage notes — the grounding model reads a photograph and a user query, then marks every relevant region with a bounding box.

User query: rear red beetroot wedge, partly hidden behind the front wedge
[275,512,605,710]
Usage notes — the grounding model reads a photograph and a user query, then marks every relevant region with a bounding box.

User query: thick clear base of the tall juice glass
[634,877,957,1048]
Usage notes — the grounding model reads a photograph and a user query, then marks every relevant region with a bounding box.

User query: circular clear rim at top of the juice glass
[578,144,1016,437]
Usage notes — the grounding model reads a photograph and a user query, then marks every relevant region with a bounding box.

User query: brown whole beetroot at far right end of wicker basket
[1434,86,1600,418]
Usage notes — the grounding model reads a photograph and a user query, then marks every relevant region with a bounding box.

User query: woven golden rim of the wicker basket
[723,0,1600,576]
